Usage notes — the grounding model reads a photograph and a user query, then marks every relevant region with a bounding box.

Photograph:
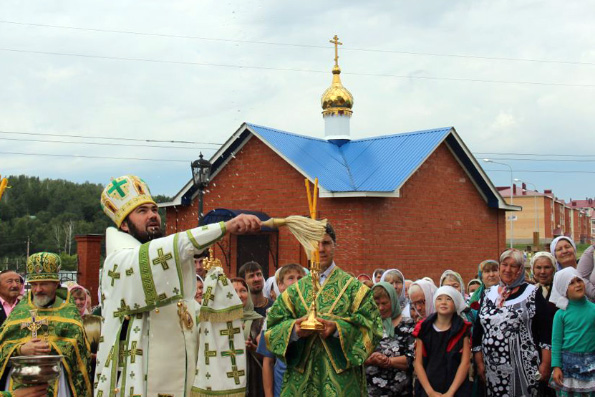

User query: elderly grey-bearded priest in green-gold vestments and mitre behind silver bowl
[0,252,92,397]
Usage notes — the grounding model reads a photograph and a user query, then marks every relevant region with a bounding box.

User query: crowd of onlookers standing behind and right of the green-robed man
[191,230,595,397]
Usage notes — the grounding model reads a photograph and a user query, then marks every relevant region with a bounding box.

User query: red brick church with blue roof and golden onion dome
[160,41,518,282]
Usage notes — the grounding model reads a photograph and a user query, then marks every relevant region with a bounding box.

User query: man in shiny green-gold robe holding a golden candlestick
[265,225,382,397]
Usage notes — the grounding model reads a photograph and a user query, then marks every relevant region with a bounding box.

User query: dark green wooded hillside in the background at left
[0,175,169,272]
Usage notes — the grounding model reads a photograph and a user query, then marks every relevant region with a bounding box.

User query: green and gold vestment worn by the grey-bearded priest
[0,288,93,397]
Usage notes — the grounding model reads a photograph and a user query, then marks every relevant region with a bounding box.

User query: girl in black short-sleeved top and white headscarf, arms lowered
[413,286,471,397]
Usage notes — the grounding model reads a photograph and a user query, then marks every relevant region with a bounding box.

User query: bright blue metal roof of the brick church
[247,124,452,193]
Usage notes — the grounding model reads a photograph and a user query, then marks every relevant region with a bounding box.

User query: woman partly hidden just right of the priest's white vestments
[231,278,264,396]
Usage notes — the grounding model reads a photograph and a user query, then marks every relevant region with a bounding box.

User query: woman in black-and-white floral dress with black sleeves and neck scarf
[472,249,551,397]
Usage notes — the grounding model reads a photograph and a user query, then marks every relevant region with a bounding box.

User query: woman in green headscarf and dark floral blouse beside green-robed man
[365,281,415,397]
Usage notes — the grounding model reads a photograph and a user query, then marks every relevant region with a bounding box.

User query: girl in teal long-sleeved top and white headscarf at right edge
[550,267,595,396]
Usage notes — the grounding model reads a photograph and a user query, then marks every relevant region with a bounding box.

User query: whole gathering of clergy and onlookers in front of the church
[0,175,595,397]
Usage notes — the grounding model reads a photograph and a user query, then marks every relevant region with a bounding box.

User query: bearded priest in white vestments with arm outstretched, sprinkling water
[95,175,260,397]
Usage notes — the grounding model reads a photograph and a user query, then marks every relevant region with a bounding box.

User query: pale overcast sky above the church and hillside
[0,0,595,204]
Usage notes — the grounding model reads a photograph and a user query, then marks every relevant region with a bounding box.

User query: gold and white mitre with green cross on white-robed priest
[101,175,157,227]
